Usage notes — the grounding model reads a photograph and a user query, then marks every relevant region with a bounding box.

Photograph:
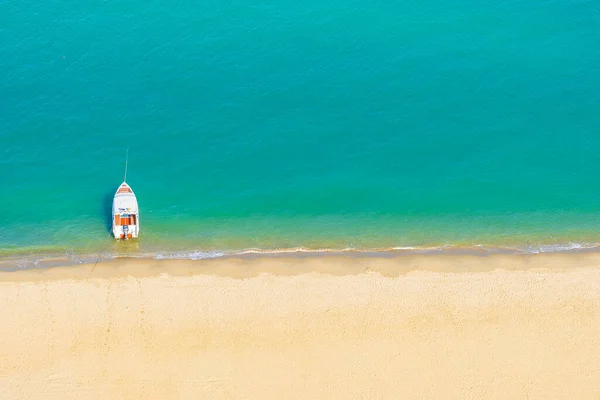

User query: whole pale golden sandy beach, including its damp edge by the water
[0,253,600,399]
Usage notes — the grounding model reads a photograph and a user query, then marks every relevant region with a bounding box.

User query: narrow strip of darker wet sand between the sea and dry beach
[0,251,600,282]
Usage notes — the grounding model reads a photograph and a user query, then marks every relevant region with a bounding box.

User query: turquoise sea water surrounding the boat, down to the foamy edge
[0,0,600,259]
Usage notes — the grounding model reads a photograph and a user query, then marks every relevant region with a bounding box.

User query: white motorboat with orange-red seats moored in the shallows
[112,152,140,240]
